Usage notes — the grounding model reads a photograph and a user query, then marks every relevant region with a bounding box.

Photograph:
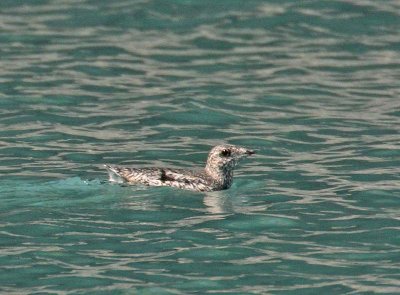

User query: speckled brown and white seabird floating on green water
[104,144,255,192]
